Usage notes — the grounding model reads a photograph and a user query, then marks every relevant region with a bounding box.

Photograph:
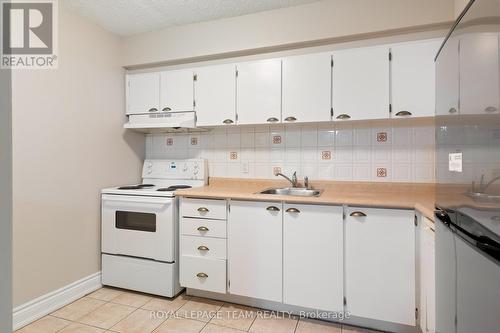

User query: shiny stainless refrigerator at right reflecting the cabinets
[436,0,500,333]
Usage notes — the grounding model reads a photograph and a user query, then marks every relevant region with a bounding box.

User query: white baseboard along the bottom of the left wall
[12,272,102,330]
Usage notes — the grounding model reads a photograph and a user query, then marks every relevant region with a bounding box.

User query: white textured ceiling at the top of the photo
[64,0,318,36]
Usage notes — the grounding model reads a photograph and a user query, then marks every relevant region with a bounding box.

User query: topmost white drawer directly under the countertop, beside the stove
[181,198,226,220]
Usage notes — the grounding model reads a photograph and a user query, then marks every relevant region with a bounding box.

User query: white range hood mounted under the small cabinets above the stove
[123,111,204,133]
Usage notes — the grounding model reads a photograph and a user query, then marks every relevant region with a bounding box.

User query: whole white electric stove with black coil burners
[101,159,208,297]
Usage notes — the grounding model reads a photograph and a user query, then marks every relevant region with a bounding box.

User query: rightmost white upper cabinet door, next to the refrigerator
[391,40,442,118]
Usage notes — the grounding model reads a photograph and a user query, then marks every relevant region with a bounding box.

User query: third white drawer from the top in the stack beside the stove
[181,236,226,259]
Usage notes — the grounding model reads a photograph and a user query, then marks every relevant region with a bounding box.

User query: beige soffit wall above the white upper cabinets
[123,0,454,66]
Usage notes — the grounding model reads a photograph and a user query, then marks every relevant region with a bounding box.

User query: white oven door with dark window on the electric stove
[101,194,176,262]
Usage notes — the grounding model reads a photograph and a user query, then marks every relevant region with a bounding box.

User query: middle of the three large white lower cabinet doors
[283,204,344,311]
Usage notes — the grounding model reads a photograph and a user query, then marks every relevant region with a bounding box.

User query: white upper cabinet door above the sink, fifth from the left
[282,53,332,122]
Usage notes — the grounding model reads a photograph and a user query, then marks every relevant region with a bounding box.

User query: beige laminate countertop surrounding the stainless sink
[175,178,435,221]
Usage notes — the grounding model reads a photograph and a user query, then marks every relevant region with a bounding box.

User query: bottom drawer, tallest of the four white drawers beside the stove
[180,256,226,293]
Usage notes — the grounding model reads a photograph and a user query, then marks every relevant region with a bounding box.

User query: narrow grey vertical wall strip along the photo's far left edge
[0,62,12,332]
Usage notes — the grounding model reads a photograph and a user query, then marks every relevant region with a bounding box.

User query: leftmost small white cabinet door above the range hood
[127,73,160,114]
